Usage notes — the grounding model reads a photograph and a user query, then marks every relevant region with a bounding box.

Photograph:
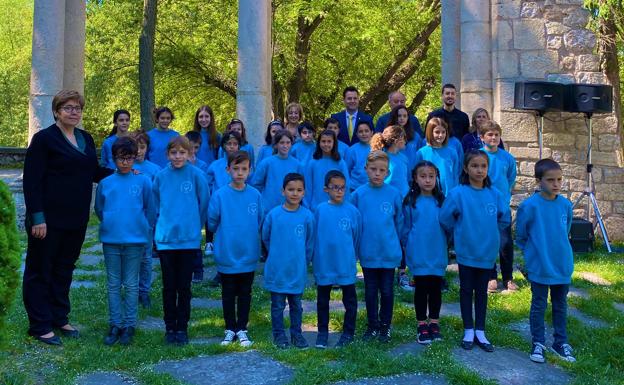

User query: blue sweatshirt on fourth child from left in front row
[262,206,314,294]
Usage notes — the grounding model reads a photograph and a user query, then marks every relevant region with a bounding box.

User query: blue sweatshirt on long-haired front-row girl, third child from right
[401,195,448,276]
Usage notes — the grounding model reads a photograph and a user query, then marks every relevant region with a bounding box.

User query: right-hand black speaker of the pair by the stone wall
[564,84,613,113]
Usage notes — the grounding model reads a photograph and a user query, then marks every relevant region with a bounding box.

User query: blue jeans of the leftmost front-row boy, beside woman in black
[102,243,145,328]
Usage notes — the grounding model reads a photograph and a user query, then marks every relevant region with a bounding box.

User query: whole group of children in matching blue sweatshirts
[95,85,575,362]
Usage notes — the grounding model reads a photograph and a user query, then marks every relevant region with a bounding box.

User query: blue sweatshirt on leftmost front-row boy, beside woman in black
[95,172,156,244]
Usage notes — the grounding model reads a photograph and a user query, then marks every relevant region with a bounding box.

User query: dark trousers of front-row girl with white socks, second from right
[459,264,490,330]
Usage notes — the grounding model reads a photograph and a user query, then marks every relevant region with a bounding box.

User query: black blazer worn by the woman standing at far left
[24,124,113,229]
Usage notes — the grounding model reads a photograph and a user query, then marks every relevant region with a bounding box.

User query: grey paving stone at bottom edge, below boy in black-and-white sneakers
[154,350,294,385]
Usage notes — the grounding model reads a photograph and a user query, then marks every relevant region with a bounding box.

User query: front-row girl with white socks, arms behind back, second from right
[439,150,511,352]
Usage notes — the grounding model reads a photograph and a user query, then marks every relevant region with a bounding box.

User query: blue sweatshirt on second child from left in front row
[152,163,210,250]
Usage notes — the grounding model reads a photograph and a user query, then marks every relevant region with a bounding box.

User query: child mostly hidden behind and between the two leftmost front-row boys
[130,131,160,308]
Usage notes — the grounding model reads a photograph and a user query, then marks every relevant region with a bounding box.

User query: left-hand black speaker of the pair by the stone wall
[514,82,565,111]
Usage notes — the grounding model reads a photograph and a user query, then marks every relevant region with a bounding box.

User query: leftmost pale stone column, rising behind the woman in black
[28,0,65,140]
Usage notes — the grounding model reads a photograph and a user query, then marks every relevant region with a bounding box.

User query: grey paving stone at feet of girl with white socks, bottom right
[453,347,572,385]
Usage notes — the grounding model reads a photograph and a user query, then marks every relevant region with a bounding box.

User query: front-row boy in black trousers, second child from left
[152,136,210,345]
